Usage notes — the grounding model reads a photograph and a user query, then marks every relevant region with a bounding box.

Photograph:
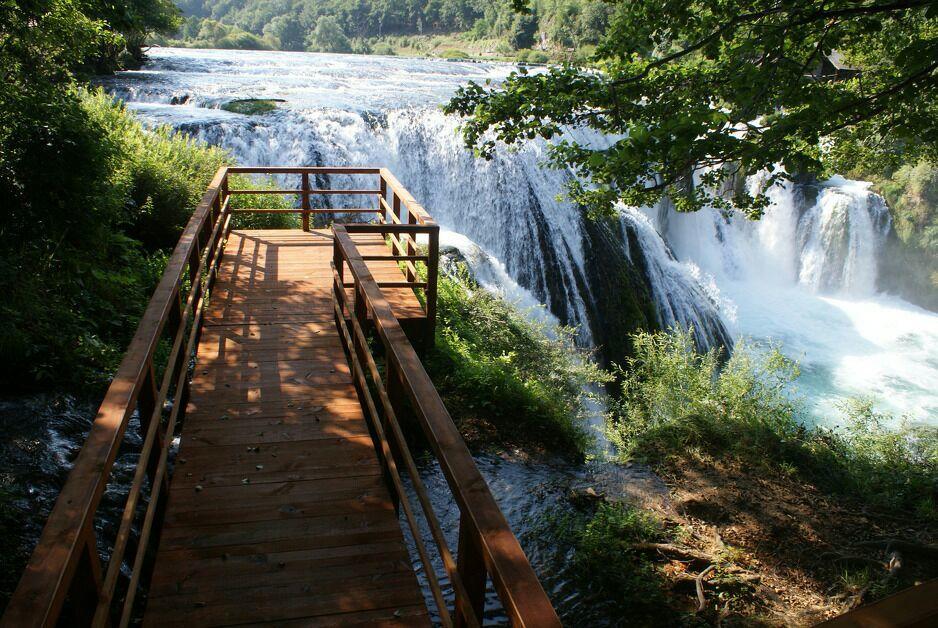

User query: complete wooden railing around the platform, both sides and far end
[0,167,557,628]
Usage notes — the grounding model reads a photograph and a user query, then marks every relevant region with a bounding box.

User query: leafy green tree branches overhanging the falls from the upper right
[446,0,938,217]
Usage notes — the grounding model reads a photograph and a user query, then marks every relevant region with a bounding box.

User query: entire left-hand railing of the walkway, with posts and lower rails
[2,168,231,628]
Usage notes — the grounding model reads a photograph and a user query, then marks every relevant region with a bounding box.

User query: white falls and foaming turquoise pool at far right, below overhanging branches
[655,177,938,422]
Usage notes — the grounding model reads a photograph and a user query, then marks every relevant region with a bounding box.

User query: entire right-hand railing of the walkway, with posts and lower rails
[332,224,560,627]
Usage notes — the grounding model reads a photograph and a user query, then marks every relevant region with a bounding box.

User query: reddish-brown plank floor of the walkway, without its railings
[144,230,429,626]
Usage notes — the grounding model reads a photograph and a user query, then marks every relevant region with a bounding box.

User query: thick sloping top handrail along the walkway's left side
[0,168,227,628]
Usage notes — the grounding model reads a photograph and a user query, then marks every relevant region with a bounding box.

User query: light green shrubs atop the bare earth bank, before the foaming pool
[609,331,938,519]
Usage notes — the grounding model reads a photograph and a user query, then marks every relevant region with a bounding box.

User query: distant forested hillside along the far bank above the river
[156,0,613,60]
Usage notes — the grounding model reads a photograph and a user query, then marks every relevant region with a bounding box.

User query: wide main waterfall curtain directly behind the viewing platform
[146,107,731,358]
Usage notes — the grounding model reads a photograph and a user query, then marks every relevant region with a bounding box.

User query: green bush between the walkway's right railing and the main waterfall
[427,266,606,455]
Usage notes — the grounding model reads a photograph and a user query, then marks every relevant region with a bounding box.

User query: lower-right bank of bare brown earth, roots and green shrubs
[555,332,938,625]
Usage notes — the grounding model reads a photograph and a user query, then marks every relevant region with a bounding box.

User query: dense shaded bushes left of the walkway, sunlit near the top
[0,91,227,389]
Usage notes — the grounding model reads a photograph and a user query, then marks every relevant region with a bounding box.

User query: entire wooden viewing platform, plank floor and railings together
[2,168,559,627]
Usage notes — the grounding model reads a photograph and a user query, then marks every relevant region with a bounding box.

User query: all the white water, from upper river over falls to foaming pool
[104,48,938,423]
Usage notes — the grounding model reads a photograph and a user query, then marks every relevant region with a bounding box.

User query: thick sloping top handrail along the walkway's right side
[333,224,560,627]
